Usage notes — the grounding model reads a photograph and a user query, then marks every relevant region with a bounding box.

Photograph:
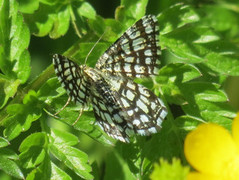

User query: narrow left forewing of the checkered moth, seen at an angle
[53,54,89,105]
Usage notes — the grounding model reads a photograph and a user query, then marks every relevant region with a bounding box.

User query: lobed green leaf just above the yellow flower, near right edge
[181,82,235,128]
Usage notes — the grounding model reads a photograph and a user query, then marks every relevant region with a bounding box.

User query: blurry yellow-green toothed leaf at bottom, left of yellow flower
[150,158,190,180]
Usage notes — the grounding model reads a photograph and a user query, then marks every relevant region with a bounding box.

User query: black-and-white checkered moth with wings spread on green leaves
[53,15,167,142]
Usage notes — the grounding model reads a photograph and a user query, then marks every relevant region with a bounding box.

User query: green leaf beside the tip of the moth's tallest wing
[158,3,200,34]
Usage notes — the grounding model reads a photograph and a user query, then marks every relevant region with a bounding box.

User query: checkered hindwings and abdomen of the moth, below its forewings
[87,70,167,142]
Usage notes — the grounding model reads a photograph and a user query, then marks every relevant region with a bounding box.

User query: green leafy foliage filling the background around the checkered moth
[0,0,239,179]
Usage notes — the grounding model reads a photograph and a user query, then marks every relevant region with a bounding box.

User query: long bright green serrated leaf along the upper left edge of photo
[0,0,30,84]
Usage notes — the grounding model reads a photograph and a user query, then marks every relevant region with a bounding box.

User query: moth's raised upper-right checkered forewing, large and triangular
[96,15,161,77]
